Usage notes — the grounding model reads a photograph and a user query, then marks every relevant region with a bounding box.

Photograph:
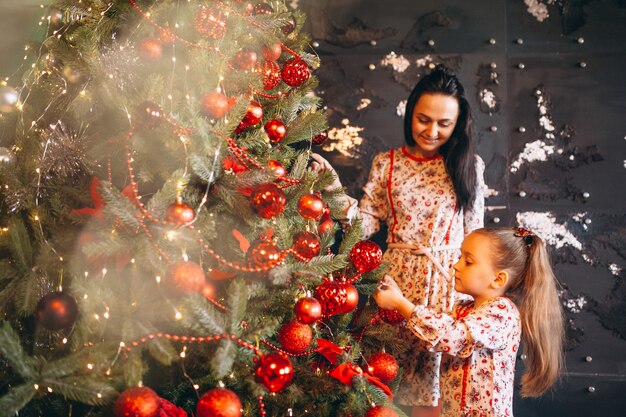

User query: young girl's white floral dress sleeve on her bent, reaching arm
[407,299,519,358]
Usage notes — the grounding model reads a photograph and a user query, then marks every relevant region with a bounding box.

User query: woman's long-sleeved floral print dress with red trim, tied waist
[359,147,485,406]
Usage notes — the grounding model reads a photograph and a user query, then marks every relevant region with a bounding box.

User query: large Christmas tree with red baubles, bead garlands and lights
[0,0,403,417]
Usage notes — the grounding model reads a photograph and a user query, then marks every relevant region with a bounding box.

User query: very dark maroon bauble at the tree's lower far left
[35,291,78,330]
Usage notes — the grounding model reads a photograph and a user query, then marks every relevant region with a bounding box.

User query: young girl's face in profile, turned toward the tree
[453,233,498,300]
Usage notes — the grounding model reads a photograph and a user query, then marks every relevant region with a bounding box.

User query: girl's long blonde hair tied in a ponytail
[475,228,565,397]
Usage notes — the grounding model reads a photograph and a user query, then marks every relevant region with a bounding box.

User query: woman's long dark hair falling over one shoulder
[404,65,478,210]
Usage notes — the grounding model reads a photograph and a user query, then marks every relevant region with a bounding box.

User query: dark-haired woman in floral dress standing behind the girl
[312,66,485,417]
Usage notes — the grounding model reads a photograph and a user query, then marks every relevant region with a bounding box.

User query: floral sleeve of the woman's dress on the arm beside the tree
[358,152,390,238]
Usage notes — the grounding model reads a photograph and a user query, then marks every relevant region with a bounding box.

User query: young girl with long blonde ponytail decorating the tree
[374,228,564,417]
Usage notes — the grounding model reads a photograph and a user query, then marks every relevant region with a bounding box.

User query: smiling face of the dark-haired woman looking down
[412,93,459,158]
